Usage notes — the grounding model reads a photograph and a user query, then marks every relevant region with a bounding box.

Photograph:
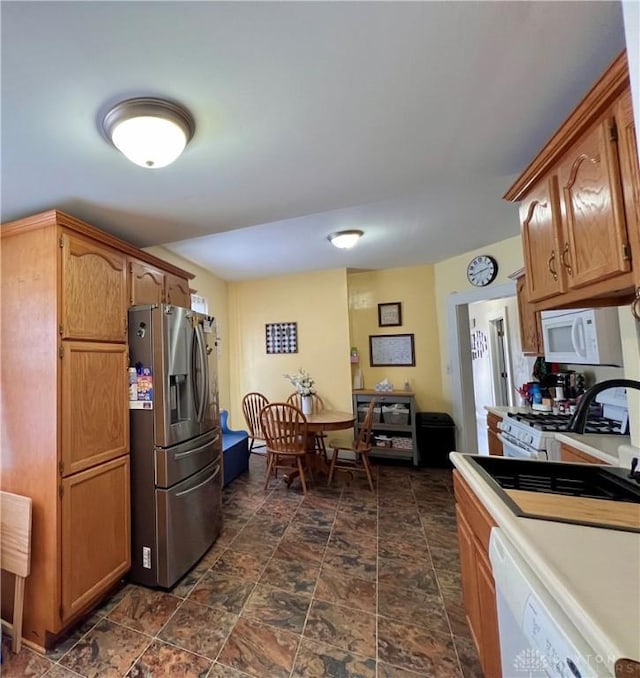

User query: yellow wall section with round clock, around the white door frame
[434,236,524,412]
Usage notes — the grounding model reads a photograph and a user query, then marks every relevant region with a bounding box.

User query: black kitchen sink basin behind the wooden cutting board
[471,456,640,504]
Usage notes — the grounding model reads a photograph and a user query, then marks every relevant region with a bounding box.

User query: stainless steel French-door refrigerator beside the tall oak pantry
[129,304,222,588]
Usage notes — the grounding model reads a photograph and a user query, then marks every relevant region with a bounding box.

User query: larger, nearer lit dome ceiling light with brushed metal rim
[102,98,196,169]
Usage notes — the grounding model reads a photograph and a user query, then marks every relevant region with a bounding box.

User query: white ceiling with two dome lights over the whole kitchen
[0,0,624,280]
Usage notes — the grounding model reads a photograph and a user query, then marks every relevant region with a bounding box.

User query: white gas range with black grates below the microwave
[498,388,629,461]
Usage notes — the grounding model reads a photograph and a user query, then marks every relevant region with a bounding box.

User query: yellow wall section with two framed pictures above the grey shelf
[348,266,446,411]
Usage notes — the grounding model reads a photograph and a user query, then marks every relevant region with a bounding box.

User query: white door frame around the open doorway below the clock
[447,280,516,453]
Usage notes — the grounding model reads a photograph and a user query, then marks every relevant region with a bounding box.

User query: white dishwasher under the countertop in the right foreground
[489,527,613,678]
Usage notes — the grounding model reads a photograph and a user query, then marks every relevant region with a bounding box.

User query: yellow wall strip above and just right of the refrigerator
[145,247,230,410]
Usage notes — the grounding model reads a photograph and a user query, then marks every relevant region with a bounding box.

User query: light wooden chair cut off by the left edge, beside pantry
[0,492,31,653]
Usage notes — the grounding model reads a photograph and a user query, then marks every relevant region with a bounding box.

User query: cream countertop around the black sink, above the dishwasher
[451,452,640,673]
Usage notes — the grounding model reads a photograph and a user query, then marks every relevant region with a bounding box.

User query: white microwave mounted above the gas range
[540,307,622,365]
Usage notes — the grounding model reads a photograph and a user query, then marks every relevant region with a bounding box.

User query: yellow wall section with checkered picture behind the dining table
[228,269,351,428]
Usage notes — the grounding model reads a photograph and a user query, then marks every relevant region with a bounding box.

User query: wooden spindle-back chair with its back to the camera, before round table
[260,403,307,494]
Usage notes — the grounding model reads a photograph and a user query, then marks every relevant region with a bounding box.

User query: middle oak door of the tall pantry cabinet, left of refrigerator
[60,341,129,476]
